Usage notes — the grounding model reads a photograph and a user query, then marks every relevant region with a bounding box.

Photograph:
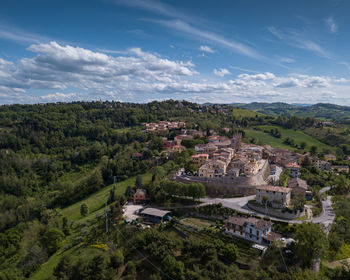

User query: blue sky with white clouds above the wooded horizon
[0,0,350,105]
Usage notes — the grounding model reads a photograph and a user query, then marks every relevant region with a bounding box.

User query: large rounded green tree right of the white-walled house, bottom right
[294,223,327,267]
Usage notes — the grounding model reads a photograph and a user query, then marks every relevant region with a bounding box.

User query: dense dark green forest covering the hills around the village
[0,100,350,279]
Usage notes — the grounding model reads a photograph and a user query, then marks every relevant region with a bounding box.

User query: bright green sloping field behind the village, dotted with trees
[245,126,336,152]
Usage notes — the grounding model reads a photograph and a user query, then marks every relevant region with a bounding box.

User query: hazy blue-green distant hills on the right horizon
[231,102,350,124]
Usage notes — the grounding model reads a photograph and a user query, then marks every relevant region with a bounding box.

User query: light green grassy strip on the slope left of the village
[60,173,152,220]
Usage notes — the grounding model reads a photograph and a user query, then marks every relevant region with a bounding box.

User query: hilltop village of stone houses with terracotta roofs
[121,121,349,251]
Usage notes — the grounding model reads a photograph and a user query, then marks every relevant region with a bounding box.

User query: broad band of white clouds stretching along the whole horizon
[0,42,350,104]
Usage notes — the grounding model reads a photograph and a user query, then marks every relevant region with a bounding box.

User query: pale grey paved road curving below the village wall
[201,187,335,233]
